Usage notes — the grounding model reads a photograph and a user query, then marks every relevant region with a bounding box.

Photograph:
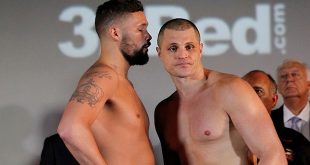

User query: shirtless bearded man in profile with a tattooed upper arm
[57,0,155,165]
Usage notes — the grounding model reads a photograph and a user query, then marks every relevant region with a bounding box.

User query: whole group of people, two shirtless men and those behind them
[41,0,310,165]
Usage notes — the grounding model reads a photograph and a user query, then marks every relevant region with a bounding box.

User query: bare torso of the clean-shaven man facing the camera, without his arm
[156,71,249,165]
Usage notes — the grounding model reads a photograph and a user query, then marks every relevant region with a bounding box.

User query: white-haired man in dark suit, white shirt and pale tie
[271,59,310,140]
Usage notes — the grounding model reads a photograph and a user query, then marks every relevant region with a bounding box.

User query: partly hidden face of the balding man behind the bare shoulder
[243,72,278,114]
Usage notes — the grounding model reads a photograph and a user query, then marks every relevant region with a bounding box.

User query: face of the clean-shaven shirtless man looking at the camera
[156,28,202,78]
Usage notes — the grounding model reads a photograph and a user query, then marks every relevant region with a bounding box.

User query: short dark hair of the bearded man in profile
[95,0,144,37]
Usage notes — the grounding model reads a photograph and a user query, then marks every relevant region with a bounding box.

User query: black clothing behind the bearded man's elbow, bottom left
[40,134,79,165]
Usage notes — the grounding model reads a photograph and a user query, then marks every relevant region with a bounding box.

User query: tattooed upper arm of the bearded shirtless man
[66,67,117,121]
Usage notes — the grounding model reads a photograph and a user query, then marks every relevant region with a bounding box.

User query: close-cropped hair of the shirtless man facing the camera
[157,18,200,46]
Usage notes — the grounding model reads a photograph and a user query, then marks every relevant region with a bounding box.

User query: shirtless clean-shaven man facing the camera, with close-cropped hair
[155,19,287,165]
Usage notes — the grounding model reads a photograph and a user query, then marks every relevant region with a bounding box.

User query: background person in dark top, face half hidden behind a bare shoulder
[243,70,310,165]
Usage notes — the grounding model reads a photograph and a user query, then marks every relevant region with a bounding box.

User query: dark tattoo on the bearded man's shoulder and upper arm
[70,71,112,107]
